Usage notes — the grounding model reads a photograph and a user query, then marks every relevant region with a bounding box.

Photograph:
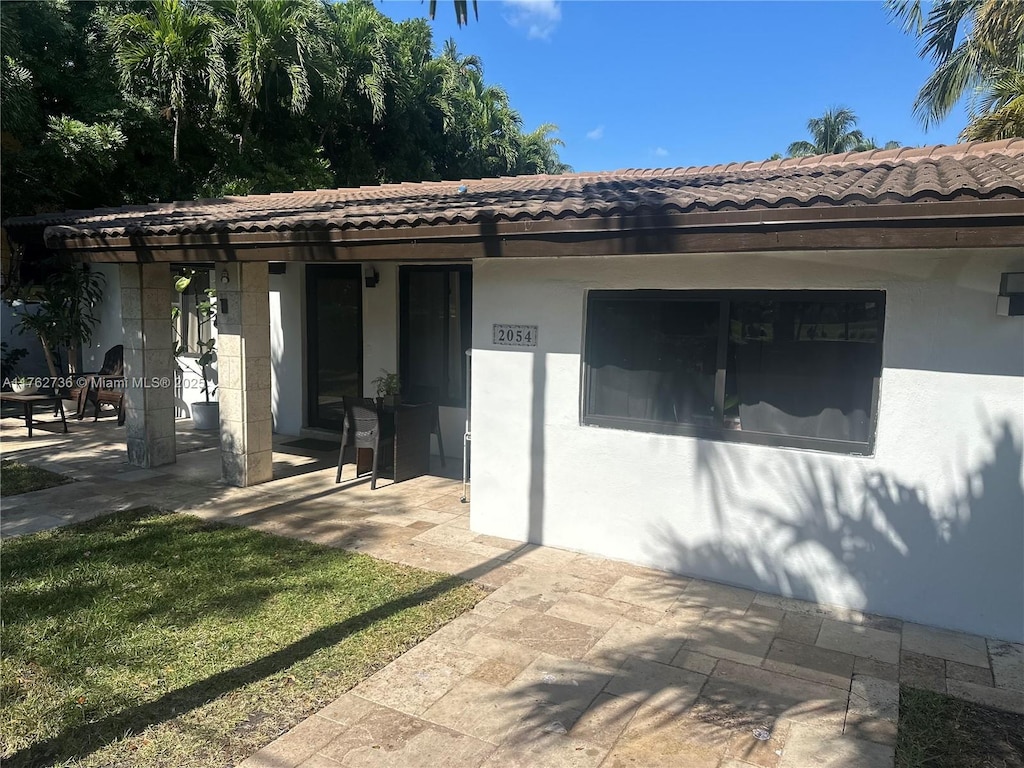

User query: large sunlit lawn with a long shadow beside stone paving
[0,510,483,768]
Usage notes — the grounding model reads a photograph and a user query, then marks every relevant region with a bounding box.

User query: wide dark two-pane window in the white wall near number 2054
[583,291,885,454]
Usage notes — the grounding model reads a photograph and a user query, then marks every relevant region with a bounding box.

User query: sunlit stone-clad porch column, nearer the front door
[214,262,273,486]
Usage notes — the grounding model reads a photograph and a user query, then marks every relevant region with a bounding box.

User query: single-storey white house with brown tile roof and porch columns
[6,139,1024,641]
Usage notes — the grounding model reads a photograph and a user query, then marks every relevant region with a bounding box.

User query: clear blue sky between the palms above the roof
[378,0,966,171]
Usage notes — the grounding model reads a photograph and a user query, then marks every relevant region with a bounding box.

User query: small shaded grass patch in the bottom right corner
[896,686,1024,768]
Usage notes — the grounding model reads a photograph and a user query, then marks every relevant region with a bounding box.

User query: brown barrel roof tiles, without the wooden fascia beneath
[5,139,1024,243]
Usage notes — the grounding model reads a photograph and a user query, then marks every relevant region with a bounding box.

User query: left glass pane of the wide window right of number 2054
[588,300,720,424]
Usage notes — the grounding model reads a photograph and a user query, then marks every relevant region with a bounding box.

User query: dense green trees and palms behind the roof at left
[0,0,570,217]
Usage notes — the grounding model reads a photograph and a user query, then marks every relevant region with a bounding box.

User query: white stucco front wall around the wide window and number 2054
[471,251,1024,641]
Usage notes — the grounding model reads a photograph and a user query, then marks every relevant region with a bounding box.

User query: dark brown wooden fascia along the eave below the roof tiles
[36,197,1024,261]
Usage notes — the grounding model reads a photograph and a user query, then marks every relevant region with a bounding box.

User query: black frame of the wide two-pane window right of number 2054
[580,289,886,456]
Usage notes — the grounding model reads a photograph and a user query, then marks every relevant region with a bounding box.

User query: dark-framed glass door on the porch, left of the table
[306,264,362,429]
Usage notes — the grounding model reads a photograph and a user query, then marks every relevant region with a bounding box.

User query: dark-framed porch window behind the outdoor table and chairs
[398,266,473,408]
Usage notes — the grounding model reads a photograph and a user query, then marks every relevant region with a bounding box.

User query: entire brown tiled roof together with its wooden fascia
[5,139,1024,261]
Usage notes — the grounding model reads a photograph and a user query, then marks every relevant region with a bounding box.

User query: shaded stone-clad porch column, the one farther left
[120,264,175,467]
